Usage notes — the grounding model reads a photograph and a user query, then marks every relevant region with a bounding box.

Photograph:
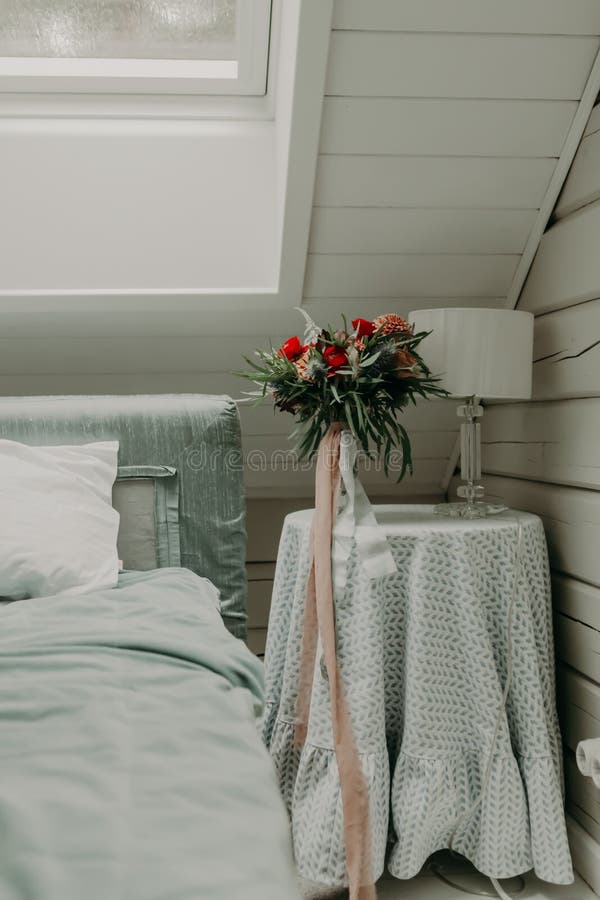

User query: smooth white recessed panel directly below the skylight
[0,119,278,292]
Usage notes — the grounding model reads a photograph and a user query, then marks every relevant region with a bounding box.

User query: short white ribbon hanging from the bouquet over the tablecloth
[332,431,397,593]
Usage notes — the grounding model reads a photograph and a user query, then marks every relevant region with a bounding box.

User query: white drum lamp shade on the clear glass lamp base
[409,308,533,400]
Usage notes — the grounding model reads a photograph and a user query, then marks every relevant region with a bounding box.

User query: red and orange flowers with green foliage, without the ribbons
[239,310,446,481]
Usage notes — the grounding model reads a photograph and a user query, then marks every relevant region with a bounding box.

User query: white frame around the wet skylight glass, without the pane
[0,0,271,97]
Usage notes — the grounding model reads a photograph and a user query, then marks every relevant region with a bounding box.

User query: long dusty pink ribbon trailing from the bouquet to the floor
[295,425,376,900]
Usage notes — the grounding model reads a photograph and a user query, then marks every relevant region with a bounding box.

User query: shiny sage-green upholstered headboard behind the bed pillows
[0,394,246,637]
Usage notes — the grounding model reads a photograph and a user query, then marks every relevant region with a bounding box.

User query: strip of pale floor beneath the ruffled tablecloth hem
[304,854,597,900]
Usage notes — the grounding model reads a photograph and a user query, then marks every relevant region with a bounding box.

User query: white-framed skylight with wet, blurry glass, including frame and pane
[0,0,271,95]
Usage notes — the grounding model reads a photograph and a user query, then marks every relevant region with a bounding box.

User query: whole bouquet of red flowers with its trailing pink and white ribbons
[239,310,446,900]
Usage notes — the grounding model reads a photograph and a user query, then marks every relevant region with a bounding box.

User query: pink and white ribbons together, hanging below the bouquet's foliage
[295,424,396,900]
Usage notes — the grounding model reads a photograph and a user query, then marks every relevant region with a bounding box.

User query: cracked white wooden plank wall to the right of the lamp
[462,96,600,880]
